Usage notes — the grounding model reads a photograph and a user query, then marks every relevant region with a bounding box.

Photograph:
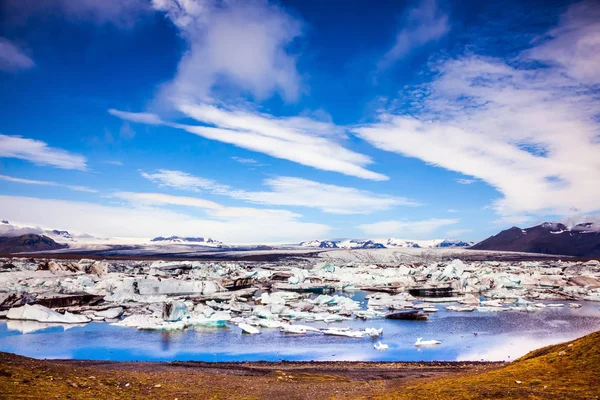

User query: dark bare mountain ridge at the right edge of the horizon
[471,222,600,257]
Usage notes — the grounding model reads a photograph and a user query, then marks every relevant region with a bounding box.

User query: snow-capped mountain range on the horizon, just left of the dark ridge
[300,238,474,249]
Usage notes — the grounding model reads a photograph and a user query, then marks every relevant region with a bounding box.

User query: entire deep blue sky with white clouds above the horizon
[0,0,600,243]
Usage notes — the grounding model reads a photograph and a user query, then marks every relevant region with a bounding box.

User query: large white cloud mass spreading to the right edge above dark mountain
[354,1,600,220]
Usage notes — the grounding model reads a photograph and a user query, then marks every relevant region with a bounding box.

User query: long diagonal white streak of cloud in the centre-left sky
[109,103,388,180]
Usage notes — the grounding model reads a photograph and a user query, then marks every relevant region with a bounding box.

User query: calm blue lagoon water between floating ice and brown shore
[0,293,600,361]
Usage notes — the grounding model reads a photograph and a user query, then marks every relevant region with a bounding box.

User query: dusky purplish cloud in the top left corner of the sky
[3,0,151,28]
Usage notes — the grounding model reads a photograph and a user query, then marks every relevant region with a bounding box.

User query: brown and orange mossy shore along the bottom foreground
[0,332,600,400]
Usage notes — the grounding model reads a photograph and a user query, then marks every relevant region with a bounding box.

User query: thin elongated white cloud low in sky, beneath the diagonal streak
[141,170,419,214]
